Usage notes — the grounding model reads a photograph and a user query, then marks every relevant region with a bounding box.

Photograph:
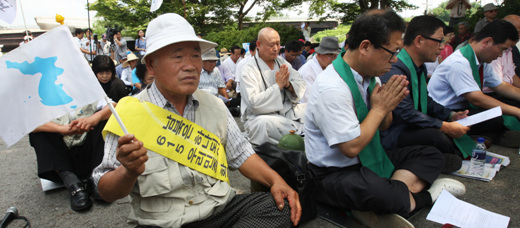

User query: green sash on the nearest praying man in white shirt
[332,52,394,178]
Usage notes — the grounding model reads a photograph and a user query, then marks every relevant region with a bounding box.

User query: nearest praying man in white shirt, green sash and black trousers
[305,10,465,227]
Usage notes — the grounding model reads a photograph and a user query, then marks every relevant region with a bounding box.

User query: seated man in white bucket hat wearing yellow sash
[92,13,301,227]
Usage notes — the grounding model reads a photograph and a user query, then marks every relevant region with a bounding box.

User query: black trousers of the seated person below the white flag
[29,121,107,182]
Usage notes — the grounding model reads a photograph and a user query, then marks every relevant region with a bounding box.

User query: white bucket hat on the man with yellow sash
[141,13,217,63]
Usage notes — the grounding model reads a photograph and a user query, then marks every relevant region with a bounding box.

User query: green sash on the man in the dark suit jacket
[397,49,476,158]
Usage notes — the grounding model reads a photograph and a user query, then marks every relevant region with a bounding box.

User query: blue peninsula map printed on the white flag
[6,57,73,106]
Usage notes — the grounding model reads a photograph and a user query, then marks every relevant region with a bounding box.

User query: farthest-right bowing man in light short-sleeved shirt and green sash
[428,20,520,142]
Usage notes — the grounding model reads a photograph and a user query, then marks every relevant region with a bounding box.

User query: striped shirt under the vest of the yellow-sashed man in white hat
[92,82,255,186]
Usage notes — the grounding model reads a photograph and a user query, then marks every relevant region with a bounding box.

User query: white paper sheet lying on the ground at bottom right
[426,190,511,228]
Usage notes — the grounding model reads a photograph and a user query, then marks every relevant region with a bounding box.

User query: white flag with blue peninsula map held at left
[0,25,106,146]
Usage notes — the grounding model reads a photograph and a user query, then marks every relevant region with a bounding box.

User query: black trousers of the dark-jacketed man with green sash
[397,128,462,157]
